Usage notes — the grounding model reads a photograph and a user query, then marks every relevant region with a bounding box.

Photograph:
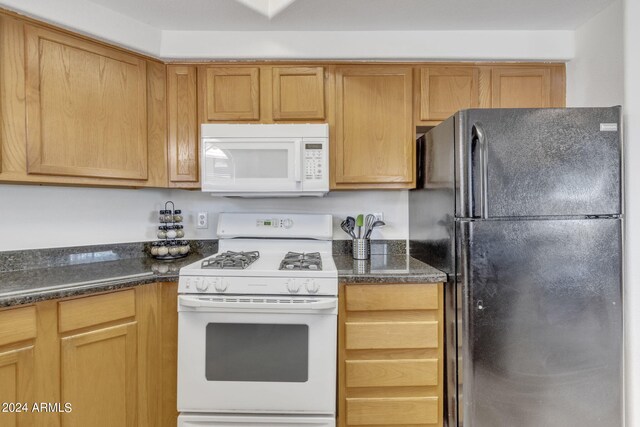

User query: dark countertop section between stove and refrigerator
[333,254,447,284]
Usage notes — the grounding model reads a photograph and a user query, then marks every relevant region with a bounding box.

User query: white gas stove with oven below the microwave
[178,213,338,427]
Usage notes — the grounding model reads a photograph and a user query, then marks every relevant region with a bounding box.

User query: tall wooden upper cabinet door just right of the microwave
[331,66,415,188]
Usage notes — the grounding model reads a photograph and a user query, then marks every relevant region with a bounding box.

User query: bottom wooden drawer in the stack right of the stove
[347,396,438,426]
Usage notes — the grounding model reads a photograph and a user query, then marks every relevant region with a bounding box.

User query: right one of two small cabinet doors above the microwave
[272,67,325,120]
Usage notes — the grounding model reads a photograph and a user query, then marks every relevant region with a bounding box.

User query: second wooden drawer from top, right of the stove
[345,321,438,350]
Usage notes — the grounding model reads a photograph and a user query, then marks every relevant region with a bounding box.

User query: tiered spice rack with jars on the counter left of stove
[150,200,191,260]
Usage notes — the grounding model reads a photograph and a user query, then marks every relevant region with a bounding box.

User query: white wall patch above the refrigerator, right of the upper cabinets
[567,0,624,107]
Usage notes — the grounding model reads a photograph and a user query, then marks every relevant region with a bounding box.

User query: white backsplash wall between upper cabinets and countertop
[0,185,409,251]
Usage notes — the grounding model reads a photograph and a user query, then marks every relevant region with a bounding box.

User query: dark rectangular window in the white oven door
[205,323,309,383]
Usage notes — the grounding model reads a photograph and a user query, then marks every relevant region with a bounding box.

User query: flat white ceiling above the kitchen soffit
[87,0,613,31]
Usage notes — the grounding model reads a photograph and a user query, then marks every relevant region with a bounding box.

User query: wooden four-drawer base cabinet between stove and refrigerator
[338,283,444,427]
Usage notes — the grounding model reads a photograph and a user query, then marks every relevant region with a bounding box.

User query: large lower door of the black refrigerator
[458,219,623,427]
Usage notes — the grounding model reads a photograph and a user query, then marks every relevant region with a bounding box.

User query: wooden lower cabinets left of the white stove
[0,283,177,427]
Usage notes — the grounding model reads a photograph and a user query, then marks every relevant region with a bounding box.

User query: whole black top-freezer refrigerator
[409,107,623,427]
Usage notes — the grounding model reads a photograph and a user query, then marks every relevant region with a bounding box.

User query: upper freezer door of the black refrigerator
[456,107,622,218]
